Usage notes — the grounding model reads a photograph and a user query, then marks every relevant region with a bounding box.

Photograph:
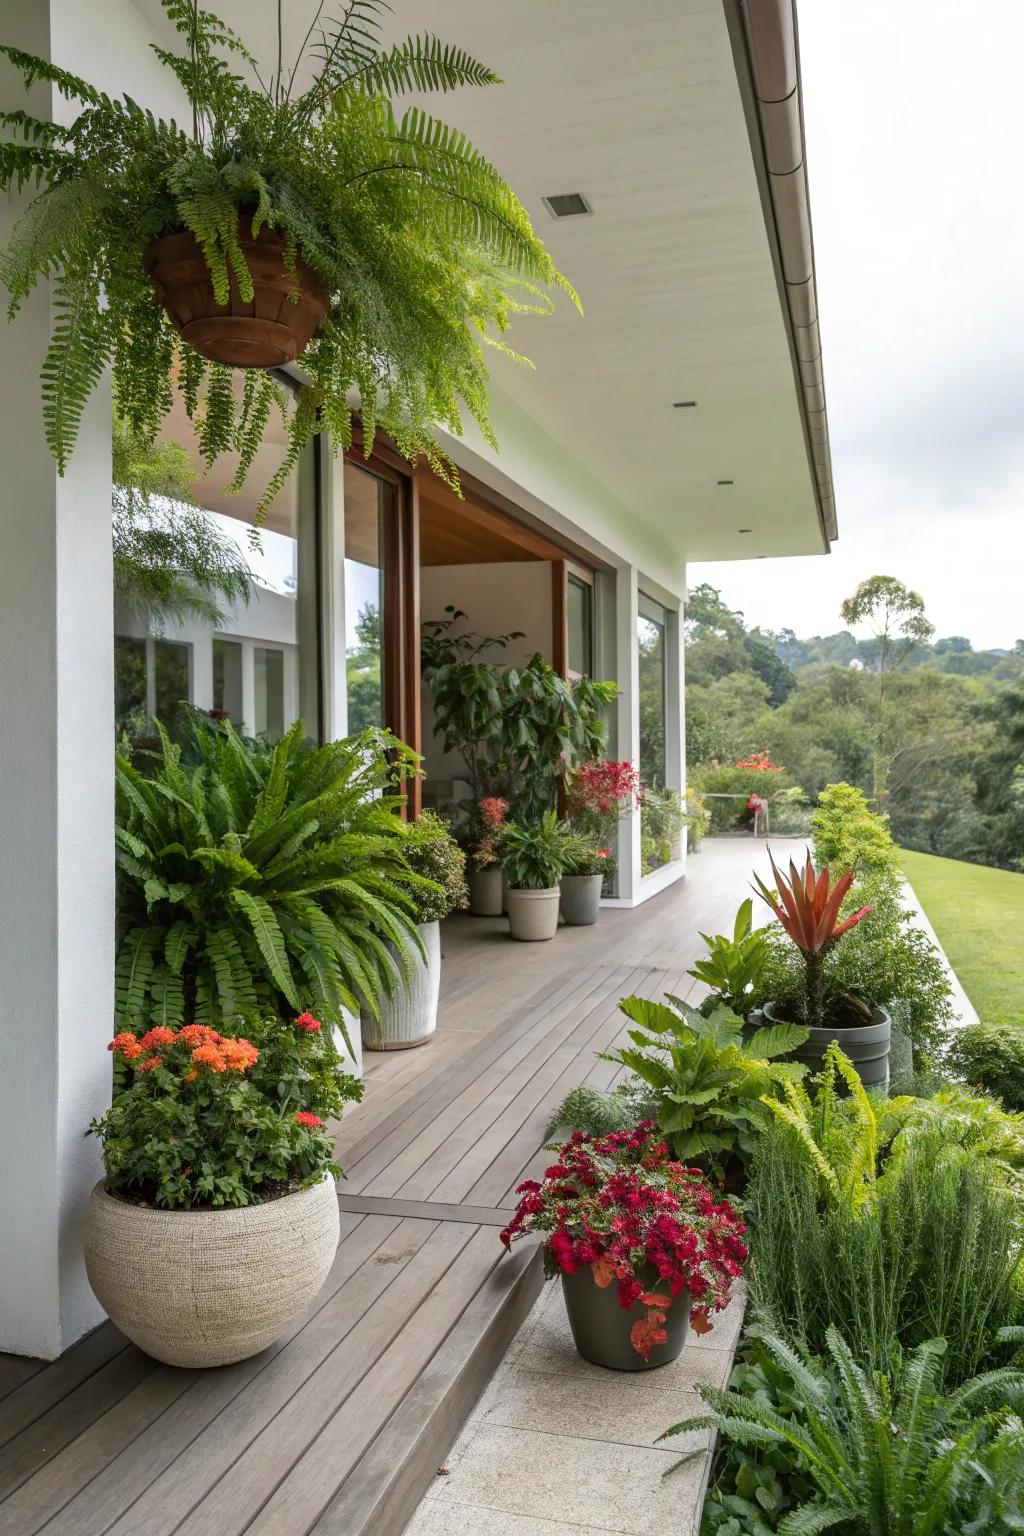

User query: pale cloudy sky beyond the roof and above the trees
[688,0,1024,648]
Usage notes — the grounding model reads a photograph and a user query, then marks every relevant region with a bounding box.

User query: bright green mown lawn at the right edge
[900,848,1024,1023]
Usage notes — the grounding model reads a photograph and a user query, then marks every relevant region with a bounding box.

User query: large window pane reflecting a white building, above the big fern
[114,378,319,737]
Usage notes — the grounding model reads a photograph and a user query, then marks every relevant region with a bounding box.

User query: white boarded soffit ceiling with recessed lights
[141,0,826,561]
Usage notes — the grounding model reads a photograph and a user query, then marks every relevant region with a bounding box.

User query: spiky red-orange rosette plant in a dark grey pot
[754,852,892,1087]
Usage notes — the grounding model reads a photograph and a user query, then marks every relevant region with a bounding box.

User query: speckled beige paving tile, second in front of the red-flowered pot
[433,1424,703,1536]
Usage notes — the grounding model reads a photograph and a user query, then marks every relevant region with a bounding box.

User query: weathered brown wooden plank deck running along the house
[0,840,763,1536]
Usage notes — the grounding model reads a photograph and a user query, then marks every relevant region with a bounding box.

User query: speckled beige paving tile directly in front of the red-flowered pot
[477,1369,711,1452]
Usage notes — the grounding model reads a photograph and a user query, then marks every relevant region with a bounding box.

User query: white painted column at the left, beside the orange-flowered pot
[0,9,114,1358]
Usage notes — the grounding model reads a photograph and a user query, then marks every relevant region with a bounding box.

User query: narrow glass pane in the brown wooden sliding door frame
[345,462,396,736]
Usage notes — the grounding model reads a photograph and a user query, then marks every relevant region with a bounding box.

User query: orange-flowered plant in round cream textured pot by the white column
[84,1014,362,1369]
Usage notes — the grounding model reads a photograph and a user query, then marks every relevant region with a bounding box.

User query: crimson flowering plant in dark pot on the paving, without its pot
[500,1120,746,1359]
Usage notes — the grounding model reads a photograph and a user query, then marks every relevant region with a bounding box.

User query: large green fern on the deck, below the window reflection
[117,722,433,1029]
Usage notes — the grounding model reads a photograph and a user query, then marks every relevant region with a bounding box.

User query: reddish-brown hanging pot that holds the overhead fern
[146,214,330,369]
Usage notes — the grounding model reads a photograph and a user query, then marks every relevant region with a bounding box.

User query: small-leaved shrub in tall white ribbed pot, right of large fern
[362,811,467,1051]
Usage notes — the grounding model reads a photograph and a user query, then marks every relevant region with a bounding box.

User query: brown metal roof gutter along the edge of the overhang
[723,0,838,550]
